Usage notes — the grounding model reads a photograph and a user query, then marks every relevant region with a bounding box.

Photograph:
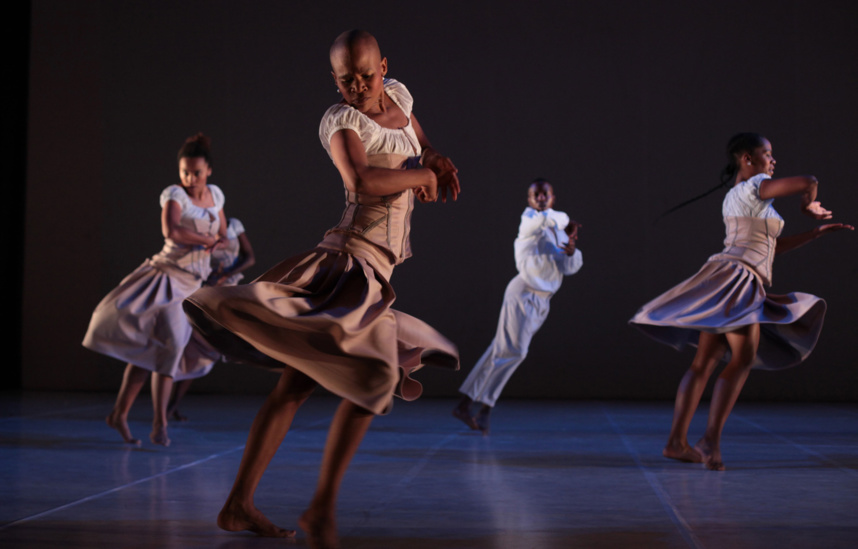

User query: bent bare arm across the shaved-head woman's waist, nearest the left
[331,130,438,200]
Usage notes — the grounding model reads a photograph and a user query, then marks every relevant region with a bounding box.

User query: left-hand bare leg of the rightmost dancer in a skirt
[662,332,727,463]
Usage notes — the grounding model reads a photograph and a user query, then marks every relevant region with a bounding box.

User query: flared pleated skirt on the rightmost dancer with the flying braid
[629,260,826,370]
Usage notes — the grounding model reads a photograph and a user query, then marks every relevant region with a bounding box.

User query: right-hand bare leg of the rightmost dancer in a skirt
[695,324,760,471]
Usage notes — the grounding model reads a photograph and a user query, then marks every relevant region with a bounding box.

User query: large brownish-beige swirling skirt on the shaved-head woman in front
[184,229,459,414]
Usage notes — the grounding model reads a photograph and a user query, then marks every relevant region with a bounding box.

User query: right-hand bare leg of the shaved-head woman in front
[298,400,373,549]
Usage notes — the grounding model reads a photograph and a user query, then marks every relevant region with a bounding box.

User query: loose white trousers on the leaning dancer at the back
[459,276,551,406]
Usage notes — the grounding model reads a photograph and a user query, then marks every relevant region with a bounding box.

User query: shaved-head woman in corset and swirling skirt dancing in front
[185,31,460,549]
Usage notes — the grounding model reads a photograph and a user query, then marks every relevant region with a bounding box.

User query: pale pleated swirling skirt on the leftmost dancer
[83,259,219,381]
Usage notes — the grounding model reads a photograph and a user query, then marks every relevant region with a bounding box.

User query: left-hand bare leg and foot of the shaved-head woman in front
[217,366,316,538]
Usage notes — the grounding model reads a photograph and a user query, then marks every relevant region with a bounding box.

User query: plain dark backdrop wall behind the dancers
[21,0,858,400]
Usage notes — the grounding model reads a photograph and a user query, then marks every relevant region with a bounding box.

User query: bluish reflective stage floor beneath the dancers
[0,393,858,549]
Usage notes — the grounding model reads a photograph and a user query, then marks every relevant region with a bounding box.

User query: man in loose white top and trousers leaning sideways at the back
[453,179,584,434]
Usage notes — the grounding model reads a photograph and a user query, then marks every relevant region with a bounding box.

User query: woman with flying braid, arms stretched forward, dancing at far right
[630,133,854,471]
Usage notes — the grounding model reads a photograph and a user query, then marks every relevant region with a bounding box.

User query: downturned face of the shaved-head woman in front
[331,41,387,113]
